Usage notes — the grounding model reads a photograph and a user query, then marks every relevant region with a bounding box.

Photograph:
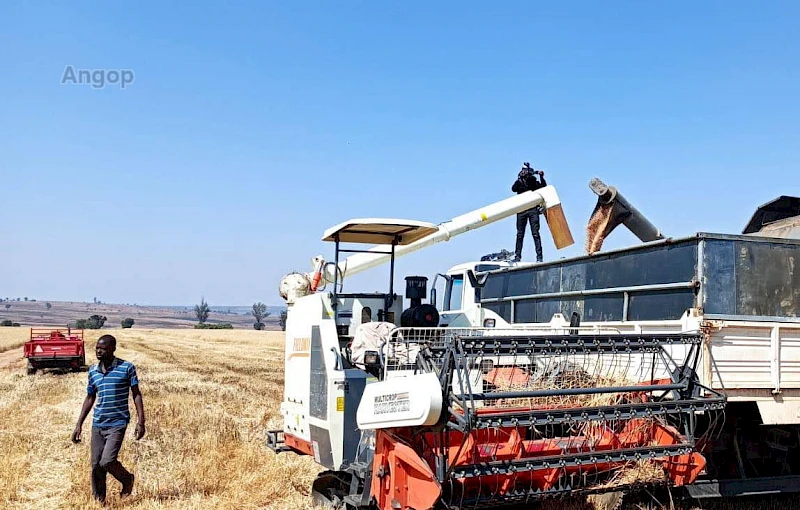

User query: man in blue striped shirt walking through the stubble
[72,335,145,503]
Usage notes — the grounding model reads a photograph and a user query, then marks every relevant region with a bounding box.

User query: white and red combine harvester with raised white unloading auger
[268,186,725,510]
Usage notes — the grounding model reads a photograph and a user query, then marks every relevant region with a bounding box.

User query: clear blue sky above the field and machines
[0,2,800,305]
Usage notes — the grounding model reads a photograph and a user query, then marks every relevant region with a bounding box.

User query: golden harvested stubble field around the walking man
[0,328,800,510]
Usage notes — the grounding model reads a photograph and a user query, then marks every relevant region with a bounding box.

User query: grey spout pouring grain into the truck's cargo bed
[586,177,664,255]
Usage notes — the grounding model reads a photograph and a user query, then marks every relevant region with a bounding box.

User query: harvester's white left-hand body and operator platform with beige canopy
[268,218,438,482]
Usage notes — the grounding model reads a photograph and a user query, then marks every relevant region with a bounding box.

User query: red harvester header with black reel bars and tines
[372,328,726,510]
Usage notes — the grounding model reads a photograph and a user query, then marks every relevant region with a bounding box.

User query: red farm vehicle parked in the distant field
[23,328,86,375]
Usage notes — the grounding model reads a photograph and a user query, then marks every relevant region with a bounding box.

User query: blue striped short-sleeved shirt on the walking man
[86,358,139,429]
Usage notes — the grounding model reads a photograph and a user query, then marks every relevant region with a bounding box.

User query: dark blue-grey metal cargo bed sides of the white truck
[480,233,800,323]
